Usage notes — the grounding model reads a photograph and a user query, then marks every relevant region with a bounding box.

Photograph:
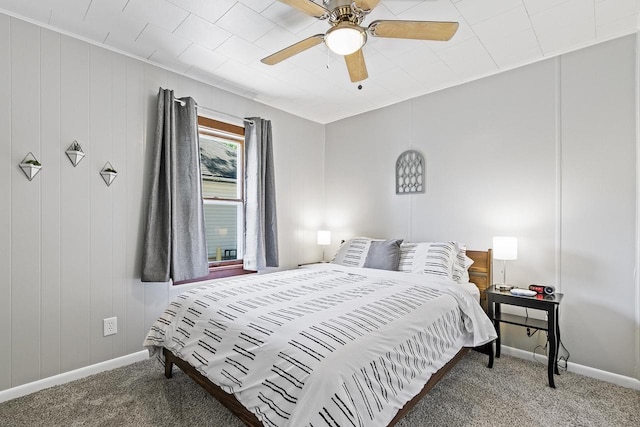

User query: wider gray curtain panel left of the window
[142,88,209,282]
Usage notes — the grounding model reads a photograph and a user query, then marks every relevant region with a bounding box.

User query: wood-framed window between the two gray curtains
[177,117,253,284]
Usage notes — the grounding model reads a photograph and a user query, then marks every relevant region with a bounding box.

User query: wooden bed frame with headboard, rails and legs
[162,249,494,427]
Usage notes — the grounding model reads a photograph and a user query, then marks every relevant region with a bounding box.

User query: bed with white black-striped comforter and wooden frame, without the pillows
[144,244,495,427]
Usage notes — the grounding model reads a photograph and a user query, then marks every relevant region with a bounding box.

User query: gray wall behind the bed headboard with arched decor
[325,36,640,378]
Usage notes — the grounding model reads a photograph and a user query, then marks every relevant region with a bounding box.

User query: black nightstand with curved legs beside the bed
[485,286,563,388]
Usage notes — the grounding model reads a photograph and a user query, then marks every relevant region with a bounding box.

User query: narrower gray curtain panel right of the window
[244,117,278,271]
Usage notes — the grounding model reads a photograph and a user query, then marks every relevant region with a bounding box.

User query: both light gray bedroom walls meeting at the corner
[0,10,640,390]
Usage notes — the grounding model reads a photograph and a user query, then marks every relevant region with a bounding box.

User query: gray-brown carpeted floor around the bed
[0,351,640,427]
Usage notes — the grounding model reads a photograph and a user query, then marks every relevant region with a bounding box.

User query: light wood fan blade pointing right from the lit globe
[367,21,459,41]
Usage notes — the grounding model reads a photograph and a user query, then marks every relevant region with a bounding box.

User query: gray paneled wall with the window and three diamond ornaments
[0,14,324,390]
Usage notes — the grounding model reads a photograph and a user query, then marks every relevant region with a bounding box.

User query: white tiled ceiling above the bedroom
[0,0,640,123]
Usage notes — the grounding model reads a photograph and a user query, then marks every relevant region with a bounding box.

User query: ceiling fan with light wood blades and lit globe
[261,0,458,82]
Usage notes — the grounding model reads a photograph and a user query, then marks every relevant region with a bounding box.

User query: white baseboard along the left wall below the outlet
[0,350,149,402]
